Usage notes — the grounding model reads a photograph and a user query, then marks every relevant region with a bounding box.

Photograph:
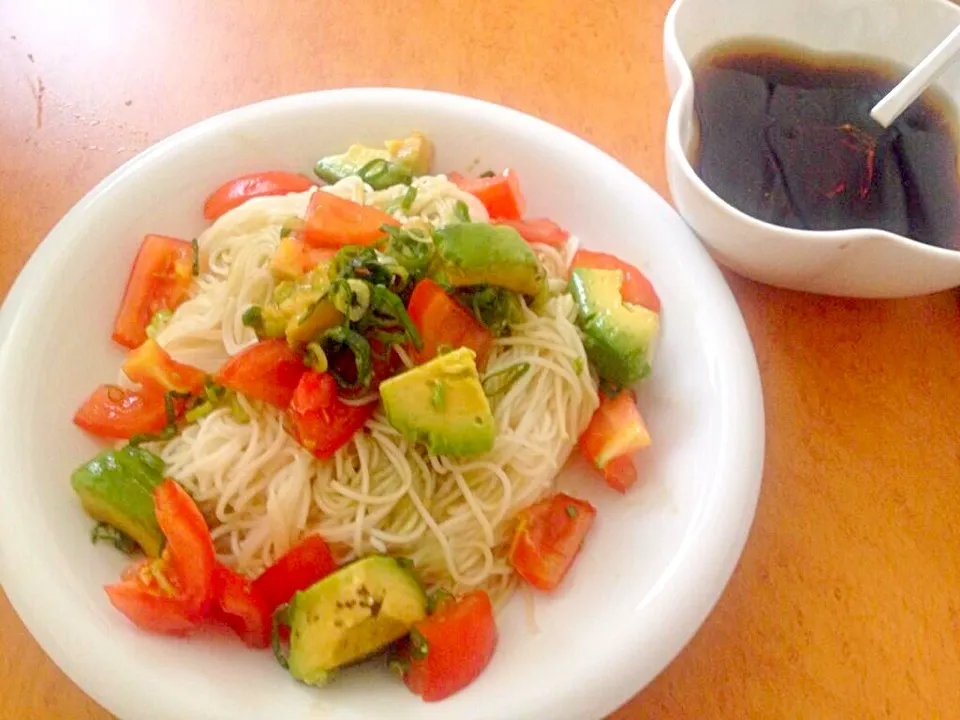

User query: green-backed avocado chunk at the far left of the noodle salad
[70,445,165,557]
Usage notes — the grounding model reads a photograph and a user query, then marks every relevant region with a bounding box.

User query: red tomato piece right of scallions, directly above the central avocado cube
[407,278,494,368]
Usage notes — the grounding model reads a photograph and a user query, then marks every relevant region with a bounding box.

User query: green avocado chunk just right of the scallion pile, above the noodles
[431,223,545,296]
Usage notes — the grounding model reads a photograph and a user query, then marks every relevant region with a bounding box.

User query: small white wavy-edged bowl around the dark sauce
[664,0,960,298]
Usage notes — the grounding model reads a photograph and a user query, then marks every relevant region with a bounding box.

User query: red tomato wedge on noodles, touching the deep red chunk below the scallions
[215,340,307,409]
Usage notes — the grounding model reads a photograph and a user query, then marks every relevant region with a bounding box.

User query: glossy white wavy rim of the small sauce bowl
[663,0,960,264]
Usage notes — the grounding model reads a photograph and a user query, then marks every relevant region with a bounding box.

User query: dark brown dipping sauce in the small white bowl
[694,41,960,249]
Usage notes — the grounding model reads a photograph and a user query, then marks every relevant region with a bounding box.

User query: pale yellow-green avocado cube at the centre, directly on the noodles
[380,348,497,456]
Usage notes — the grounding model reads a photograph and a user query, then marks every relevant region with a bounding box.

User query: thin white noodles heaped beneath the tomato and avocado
[151,175,597,605]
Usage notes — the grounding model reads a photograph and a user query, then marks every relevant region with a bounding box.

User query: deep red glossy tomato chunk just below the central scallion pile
[287,370,377,460]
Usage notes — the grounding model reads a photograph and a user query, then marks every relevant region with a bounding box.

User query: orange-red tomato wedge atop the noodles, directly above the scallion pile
[303,190,400,248]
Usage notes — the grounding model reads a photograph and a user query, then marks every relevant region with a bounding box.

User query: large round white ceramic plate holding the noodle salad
[0,89,763,720]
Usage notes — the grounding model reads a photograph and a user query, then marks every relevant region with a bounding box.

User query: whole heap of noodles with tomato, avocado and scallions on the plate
[72,133,660,700]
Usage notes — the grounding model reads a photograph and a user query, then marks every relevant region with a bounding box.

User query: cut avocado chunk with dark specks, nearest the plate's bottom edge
[287,555,427,685]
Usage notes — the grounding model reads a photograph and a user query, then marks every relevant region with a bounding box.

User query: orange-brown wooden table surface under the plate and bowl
[0,0,960,720]
